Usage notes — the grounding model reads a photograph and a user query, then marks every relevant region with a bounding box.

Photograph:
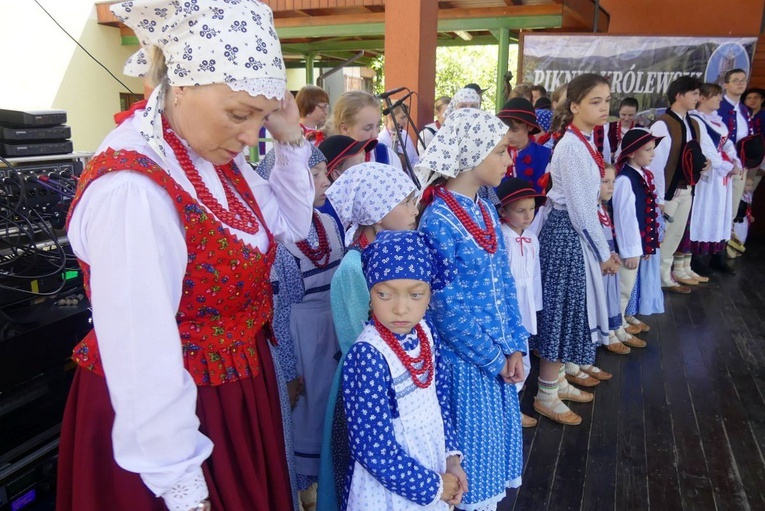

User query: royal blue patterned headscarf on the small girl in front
[361,231,452,289]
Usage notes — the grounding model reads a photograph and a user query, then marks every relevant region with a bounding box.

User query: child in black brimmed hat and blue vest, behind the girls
[497,98,552,193]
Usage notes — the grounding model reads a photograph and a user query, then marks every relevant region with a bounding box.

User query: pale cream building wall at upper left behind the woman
[0,0,143,152]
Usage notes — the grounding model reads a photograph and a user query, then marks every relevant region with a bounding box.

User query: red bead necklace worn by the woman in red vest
[162,116,260,234]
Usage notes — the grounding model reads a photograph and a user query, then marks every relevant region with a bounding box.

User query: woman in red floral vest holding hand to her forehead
[56,0,314,511]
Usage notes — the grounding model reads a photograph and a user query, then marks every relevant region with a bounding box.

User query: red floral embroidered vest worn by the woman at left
[67,148,276,386]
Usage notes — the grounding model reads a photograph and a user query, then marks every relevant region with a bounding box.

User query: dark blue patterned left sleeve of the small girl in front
[342,342,443,506]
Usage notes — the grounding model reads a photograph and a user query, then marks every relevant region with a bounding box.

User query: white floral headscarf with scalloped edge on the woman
[110,0,287,166]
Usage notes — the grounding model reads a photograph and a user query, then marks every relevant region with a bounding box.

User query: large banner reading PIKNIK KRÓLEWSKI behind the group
[521,34,757,123]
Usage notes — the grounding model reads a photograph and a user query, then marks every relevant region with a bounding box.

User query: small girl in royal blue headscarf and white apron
[342,231,468,511]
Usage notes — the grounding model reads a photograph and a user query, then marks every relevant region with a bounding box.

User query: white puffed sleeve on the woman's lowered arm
[68,172,212,511]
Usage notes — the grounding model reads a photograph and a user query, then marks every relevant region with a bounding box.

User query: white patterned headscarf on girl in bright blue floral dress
[414,108,509,189]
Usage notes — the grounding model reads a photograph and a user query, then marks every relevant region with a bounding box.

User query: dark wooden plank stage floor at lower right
[498,246,765,511]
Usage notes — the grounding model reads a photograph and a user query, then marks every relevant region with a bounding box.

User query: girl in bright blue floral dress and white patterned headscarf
[417,108,528,511]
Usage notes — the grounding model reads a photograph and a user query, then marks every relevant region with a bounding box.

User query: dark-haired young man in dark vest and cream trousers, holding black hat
[644,76,709,294]
